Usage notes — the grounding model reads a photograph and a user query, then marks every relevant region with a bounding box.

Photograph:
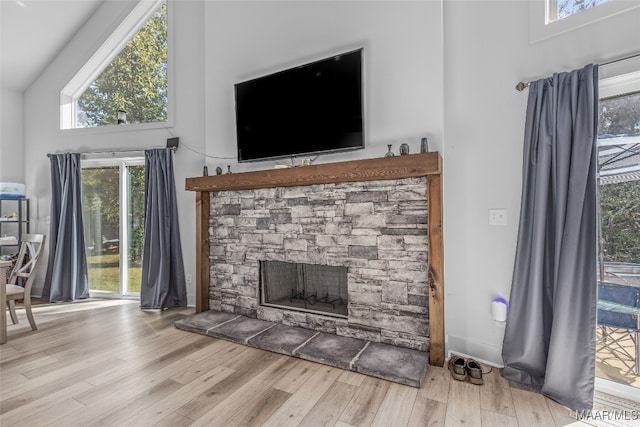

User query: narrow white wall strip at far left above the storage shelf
[0,88,25,183]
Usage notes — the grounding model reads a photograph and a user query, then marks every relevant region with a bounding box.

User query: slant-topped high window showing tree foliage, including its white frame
[61,0,168,129]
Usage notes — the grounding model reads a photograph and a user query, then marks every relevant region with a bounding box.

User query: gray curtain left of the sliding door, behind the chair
[42,153,89,302]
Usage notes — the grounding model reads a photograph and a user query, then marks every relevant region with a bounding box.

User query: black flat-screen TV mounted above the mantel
[235,49,364,162]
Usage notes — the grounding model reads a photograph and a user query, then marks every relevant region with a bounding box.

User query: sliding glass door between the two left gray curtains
[82,159,144,296]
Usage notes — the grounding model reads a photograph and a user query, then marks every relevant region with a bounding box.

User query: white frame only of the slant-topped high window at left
[60,0,175,133]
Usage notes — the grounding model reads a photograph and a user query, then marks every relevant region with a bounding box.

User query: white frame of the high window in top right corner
[529,0,640,43]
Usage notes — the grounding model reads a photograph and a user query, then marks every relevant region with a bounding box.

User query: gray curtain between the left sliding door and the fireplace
[140,148,187,309]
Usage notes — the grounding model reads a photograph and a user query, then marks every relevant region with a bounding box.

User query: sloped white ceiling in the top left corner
[0,0,105,92]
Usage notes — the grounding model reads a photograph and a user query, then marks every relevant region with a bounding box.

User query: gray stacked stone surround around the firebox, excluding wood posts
[209,177,429,351]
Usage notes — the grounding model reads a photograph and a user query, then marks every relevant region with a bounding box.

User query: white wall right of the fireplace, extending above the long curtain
[444,0,640,364]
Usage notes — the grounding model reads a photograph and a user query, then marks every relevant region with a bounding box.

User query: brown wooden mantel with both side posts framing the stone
[185,152,444,366]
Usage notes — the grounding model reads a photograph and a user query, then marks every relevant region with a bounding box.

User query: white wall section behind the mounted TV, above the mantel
[205,1,443,170]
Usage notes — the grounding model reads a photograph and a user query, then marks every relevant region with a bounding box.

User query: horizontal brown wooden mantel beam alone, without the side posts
[186,152,442,191]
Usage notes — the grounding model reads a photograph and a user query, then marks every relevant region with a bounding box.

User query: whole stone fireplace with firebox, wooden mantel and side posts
[187,153,444,365]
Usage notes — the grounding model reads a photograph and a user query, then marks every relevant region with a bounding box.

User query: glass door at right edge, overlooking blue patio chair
[596,84,640,395]
